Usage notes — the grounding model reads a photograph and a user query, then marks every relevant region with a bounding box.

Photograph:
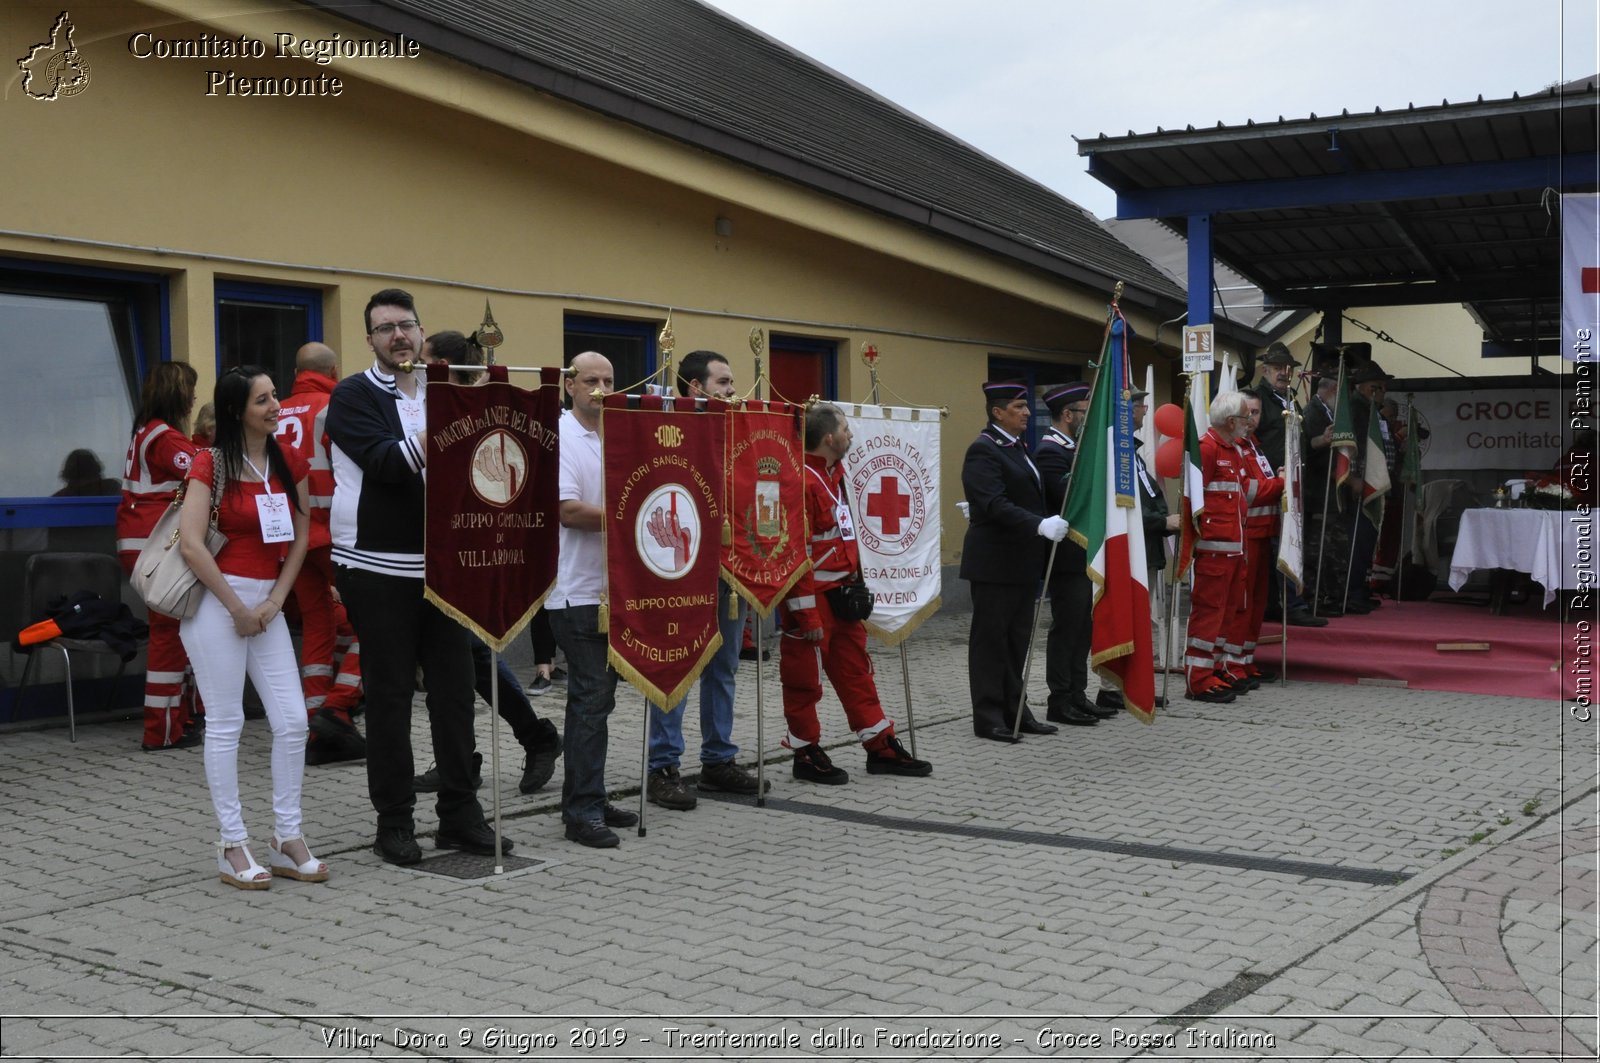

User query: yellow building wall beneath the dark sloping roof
[0,0,1154,559]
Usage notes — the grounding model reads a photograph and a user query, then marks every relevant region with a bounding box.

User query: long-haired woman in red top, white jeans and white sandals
[179,365,328,890]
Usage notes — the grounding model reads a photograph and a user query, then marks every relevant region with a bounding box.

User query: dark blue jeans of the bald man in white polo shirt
[549,605,616,823]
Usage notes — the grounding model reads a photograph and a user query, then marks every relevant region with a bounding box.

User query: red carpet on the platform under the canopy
[1256,594,1595,700]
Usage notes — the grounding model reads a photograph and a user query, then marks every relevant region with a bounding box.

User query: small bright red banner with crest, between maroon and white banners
[722,400,811,616]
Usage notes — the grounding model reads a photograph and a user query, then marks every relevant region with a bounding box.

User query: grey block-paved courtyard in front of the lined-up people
[0,612,1600,1060]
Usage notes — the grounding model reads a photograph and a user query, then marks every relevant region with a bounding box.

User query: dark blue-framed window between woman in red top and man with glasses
[214,280,322,395]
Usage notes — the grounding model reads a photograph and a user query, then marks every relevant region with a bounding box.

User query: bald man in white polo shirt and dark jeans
[544,351,638,848]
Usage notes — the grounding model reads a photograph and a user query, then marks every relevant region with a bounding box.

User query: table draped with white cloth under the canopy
[1450,509,1594,613]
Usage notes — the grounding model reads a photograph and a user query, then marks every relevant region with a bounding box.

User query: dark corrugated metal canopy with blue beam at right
[1078,78,1600,354]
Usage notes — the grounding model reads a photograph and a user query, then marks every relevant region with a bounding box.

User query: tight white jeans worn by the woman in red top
[178,573,307,845]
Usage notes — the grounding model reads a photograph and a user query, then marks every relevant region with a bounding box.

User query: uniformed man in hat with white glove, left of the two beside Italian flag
[962,381,1067,741]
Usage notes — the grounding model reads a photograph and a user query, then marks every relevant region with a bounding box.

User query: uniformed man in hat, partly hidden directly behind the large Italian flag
[1034,381,1117,727]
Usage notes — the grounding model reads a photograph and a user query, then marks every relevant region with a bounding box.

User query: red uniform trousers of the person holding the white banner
[778,594,894,749]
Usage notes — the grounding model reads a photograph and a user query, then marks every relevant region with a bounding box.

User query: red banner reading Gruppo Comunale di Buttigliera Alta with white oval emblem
[600,395,728,711]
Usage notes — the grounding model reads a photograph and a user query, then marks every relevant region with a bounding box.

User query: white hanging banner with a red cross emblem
[840,405,942,645]
